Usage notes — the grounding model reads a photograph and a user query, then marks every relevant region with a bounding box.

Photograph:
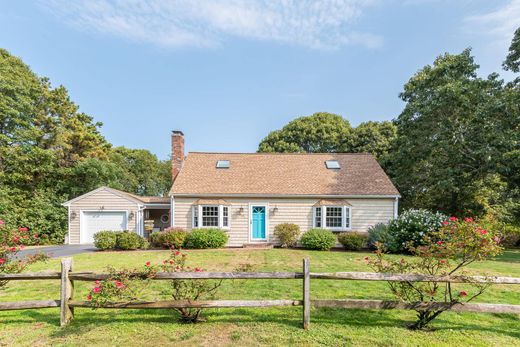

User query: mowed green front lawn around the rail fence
[0,249,520,347]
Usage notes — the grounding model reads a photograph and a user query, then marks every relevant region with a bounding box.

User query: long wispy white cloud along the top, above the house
[41,0,382,49]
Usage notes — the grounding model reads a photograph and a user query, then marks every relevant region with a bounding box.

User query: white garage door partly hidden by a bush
[81,211,128,243]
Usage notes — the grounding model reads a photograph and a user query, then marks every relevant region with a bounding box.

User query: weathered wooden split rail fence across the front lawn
[0,258,520,329]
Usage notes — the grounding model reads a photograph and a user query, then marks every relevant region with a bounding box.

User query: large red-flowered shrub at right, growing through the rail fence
[365,217,502,329]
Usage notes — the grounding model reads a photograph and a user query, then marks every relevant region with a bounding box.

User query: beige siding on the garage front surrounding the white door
[68,190,138,244]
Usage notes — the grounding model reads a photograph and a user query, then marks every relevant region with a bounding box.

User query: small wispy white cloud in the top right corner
[466,0,520,46]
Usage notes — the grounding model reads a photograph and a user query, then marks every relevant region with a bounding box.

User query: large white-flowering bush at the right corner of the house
[385,209,448,253]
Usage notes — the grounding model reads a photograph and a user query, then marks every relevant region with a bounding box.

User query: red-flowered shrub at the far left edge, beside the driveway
[0,220,48,289]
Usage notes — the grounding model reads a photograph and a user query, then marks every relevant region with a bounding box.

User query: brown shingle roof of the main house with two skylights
[170,152,399,196]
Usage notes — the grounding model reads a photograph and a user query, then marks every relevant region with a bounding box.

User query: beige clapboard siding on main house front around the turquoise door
[174,197,395,247]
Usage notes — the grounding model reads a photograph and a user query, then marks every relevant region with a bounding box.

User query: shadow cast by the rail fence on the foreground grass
[0,308,520,338]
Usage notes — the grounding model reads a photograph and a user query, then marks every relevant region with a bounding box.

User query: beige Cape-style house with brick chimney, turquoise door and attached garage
[64,131,400,247]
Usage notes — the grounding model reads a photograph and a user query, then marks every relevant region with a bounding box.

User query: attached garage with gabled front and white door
[63,187,145,244]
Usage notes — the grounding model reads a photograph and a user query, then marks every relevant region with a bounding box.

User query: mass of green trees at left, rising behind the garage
[0,49,171,242]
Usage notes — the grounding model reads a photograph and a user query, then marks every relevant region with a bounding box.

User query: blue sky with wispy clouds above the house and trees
[0,0,520,158]
